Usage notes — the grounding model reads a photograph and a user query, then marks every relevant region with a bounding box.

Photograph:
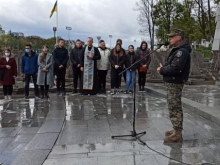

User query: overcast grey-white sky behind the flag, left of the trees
[0,0,148,48]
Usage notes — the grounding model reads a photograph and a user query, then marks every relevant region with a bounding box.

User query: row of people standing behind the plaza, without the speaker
[0,37,151,100]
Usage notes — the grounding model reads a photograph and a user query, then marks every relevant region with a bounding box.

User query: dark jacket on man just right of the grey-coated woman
[53,47,69,68]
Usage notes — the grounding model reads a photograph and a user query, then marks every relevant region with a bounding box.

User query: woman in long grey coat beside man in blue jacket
[37,45,53,99]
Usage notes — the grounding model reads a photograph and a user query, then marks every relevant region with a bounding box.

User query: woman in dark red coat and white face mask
[0,49,17,100]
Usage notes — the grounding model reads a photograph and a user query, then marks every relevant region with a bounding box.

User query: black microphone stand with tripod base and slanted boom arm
[112,44,165,145]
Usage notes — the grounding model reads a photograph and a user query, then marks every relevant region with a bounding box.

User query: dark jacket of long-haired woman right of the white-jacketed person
[109,49,125,68]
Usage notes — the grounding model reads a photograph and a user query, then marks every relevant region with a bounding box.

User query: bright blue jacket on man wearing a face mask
[21,51,38,74]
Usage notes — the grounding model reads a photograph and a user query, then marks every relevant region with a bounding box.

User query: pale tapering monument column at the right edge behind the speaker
[212,2,220,51]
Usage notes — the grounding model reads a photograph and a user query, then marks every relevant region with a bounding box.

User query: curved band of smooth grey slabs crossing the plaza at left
[12,95,66,165]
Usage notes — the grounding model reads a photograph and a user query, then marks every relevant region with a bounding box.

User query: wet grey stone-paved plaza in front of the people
[0,88,220,165]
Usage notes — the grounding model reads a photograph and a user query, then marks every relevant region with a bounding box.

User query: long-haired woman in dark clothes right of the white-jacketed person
[109,44,124,95]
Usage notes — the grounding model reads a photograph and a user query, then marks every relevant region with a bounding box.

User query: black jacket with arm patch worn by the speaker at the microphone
[160,41,192,84]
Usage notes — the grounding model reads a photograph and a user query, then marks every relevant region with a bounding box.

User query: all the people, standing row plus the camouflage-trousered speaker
[0,29,192,143]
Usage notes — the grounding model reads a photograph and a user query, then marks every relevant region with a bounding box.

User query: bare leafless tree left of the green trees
[135,0,158,50]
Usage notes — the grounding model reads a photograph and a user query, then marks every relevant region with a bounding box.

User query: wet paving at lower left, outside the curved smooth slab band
[0,99,50,165]
